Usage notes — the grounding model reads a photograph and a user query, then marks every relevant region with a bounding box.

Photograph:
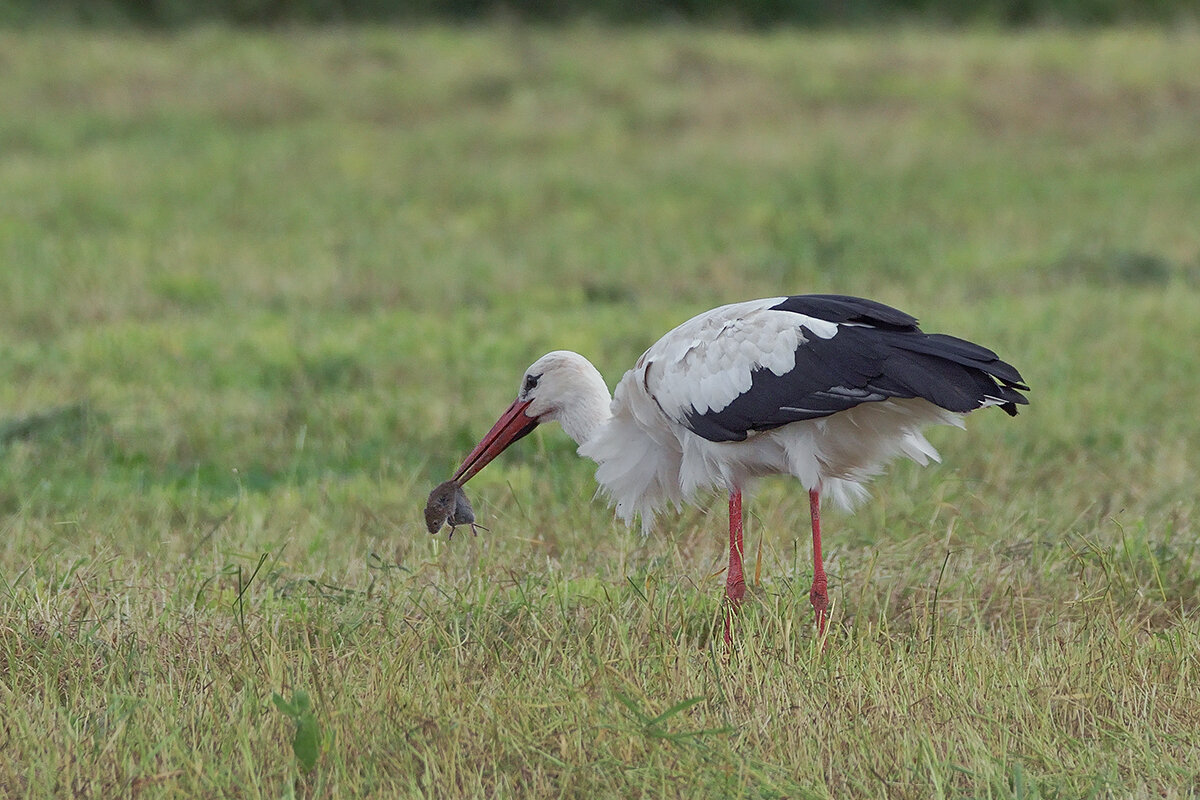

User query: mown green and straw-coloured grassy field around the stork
[0,21,1200,799]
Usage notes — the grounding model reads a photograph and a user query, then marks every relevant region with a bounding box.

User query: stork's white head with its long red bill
[454,350,611,483]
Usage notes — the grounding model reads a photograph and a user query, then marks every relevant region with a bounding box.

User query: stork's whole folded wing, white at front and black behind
[638,295,1028,441]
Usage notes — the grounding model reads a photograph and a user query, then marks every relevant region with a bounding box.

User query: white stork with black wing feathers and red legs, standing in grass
[454,295,1028,642]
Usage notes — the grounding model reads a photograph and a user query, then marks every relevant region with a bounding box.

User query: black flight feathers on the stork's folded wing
[685,295,1028,441]
